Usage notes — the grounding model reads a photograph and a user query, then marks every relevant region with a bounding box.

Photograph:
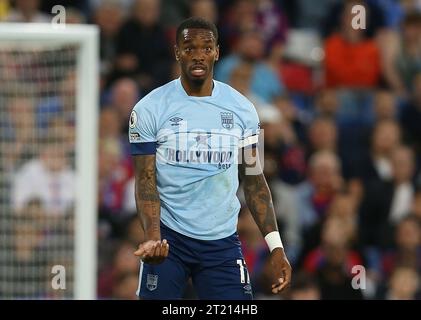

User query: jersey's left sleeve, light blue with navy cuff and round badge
[129,103,157,155]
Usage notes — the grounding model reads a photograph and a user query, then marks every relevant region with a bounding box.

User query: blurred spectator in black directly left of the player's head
[111,0,172,93]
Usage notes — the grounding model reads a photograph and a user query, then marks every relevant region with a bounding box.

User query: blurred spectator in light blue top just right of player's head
[215,31,283,103]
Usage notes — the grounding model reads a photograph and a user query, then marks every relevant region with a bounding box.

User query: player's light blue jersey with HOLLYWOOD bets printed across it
[129,79,259,240]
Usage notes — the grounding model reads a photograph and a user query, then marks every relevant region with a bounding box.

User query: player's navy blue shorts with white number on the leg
[137,223,253,300]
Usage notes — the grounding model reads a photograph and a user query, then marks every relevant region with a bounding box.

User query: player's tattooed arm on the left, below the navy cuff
[134,155,161,240]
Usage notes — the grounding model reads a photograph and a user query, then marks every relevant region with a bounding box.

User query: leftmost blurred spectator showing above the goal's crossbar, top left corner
[5,0,51,23]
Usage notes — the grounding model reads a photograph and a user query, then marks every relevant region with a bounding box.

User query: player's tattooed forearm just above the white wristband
[244,174,278,236]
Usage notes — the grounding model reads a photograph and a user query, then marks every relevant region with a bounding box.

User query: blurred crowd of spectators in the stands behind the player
[0,0,421,299]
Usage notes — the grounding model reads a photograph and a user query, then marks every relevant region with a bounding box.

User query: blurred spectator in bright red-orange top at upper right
[324,1,381,88]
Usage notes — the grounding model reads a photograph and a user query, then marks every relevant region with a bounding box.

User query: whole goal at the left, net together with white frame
[0,24,98,299]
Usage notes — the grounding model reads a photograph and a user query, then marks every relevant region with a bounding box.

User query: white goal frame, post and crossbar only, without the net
[0,23,99,299]
